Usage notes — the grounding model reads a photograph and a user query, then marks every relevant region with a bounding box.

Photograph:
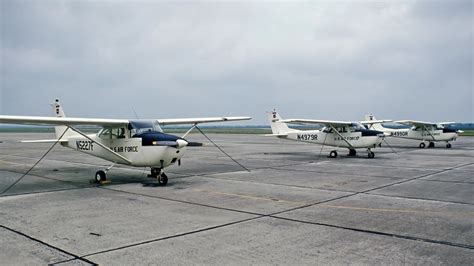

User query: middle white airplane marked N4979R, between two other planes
[267,110,384,158]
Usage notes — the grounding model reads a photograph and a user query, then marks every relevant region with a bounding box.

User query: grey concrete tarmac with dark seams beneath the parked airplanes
[0,133,474,265]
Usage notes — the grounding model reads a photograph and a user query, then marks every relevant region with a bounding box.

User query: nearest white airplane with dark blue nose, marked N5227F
[0,99,251,185]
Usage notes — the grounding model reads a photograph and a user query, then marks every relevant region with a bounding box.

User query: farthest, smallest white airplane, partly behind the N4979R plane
[365,114,463,148]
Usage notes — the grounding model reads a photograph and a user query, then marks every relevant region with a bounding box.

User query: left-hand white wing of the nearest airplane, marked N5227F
[0,115,129,127]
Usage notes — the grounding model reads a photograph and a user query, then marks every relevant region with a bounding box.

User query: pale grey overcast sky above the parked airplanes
[0,0,474,124]
